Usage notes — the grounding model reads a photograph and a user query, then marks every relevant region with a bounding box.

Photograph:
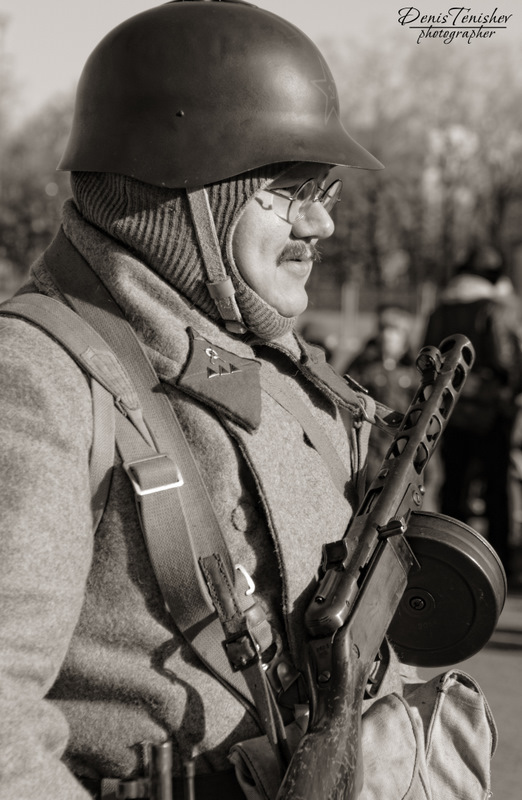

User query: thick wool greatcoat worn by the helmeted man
[0,204,406,800]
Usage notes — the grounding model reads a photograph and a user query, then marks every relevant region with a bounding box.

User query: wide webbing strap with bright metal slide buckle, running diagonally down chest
[45,232,282,727]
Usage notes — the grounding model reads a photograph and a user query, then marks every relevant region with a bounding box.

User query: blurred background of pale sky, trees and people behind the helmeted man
[0,0,522,800]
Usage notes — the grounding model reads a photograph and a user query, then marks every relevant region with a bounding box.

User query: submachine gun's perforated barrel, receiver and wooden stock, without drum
[277,335,474,800]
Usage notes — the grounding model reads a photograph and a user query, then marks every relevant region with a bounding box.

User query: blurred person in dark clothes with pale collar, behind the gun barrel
[425,244,522,579]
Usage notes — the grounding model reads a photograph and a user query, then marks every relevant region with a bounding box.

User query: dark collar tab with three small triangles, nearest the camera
[178,328,261,430]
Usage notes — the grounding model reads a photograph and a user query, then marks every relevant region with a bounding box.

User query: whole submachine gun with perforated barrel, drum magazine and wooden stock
[277,335,506,800]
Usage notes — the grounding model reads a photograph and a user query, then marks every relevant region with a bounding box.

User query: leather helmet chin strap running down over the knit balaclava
[187,186,247,334]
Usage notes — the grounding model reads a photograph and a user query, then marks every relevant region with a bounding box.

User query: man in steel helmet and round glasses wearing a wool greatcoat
[0,0,496,800]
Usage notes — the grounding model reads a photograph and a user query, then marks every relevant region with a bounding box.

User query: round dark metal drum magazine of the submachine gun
[387,511,507,667]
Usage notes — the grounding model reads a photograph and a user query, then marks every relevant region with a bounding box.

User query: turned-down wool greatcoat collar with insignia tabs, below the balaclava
[59,204,364,430]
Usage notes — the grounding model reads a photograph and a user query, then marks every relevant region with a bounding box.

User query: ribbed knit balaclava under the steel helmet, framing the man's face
[71,164,295,340]
